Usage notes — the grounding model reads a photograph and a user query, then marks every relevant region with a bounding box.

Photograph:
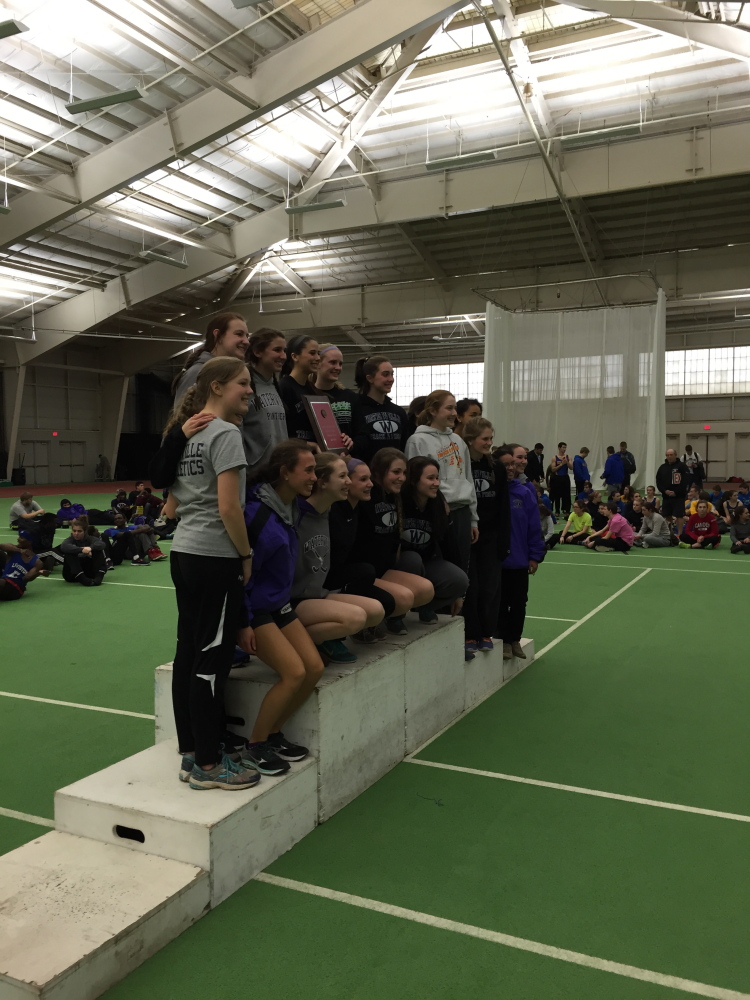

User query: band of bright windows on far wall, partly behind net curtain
[393,346,750,407]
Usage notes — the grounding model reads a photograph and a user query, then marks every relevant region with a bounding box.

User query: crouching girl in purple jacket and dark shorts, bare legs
[239,439,323,774]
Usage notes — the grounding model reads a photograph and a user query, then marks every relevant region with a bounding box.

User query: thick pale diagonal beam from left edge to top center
[2,0,462,250]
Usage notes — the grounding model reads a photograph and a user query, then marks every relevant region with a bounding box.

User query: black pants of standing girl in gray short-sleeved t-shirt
[170,551,243,765]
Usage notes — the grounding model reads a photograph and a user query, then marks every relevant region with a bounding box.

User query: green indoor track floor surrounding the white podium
[0,516,750,1000]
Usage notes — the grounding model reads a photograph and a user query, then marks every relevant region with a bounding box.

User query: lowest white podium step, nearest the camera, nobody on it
[0,832,209,1000]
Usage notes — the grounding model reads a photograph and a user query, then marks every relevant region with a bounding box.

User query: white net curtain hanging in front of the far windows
[484,286,666,489]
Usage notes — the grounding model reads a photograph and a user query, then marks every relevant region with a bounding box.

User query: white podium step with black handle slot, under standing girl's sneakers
[55,740,317,906]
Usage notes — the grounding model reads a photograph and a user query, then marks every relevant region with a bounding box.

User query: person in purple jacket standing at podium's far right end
[496,445,545,660]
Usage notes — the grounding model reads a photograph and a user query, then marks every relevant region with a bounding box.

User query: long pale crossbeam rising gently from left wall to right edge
[19,122,750,331]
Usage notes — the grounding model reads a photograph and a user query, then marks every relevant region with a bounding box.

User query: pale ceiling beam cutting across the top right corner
[563,0,750,60]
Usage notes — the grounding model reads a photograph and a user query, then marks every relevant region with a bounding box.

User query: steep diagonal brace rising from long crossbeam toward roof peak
[294,21,442,205]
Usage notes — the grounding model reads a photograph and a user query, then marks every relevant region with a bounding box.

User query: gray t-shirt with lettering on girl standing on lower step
[171,417,247,559]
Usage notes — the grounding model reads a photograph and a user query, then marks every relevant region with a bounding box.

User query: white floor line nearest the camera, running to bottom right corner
[255,872,750,1000]
